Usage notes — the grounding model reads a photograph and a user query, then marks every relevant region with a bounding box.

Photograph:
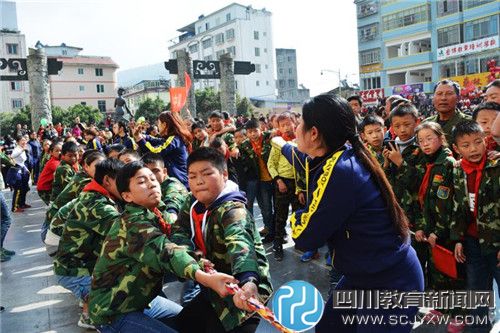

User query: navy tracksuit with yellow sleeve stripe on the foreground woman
[282,144,424,332]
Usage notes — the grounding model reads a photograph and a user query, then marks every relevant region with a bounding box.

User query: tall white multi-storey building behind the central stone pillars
[168,3,276,98]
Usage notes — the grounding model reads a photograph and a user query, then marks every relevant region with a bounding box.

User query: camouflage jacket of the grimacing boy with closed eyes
[89,204,200,325]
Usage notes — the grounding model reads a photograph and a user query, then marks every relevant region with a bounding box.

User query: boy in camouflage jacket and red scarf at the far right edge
[451,121,500,331]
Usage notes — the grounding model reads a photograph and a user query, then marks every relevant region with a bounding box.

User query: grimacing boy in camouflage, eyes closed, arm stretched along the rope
[89,161,236,332]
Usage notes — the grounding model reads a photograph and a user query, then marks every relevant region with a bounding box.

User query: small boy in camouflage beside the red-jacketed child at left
[50,141,80,201]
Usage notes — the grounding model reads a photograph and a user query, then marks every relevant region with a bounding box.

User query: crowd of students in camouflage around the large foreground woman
[2,80,500,332]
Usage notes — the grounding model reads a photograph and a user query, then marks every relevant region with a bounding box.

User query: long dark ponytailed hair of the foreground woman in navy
[302,94,409,239]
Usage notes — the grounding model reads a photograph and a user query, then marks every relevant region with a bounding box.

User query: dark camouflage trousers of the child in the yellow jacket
[274,179,300,245]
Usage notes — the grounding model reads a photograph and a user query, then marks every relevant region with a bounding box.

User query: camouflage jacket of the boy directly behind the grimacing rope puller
[54,181,120,276]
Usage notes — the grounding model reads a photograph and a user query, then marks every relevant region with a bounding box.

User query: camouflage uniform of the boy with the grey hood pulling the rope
[171,195,272,331]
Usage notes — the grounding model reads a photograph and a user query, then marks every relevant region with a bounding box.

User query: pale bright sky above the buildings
[12,0,358,95]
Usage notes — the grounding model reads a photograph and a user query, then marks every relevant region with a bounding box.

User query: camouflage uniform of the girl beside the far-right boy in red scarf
[415,148,464,290]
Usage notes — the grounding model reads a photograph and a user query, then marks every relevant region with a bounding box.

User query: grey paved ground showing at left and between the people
[0,191,499,333]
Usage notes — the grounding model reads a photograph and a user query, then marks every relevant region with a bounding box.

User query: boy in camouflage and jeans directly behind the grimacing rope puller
[54,160,122,328]
